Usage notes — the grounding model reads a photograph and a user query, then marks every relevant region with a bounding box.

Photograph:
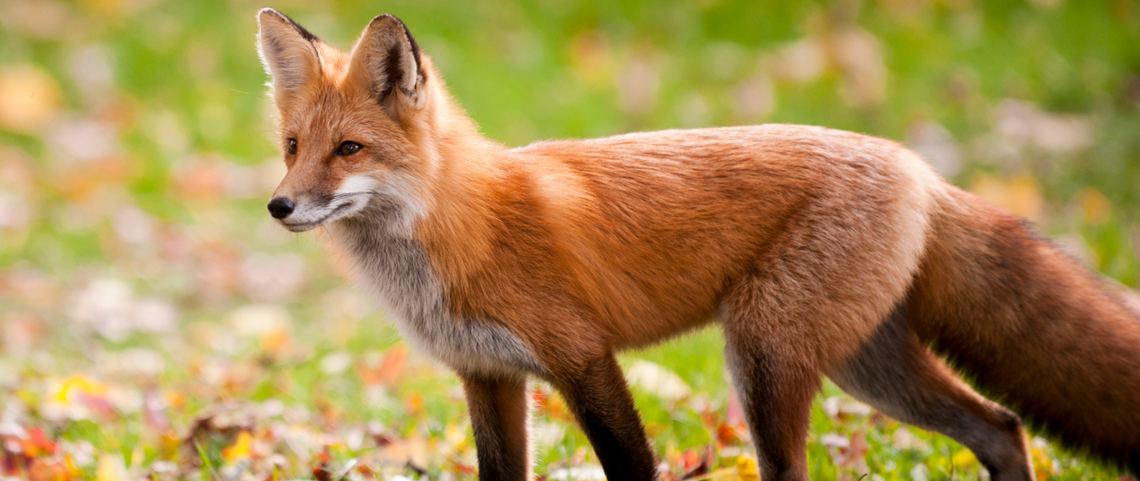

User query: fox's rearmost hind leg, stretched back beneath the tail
[827,307,1034,481]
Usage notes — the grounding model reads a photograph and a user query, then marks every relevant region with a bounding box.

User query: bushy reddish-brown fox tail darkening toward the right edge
[907,189,1140,474]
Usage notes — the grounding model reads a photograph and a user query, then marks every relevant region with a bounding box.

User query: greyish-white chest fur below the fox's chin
[328,185,542,374]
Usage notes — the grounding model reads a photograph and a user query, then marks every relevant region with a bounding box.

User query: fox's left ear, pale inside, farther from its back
[258,8,320,105]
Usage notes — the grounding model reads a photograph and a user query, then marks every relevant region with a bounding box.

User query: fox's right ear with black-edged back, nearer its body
[349,14,426,114]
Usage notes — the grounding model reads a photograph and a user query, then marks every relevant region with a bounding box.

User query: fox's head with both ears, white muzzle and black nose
[258,8,446,233]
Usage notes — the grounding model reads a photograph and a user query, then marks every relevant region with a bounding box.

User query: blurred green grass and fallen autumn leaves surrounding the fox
[0,0,1140,481]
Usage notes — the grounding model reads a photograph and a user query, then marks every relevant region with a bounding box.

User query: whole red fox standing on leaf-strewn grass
[259,9,1140,481]
